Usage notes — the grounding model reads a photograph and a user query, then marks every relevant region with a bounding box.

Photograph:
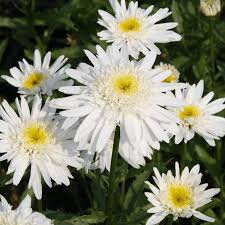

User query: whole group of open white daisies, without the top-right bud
[0,0,225,225]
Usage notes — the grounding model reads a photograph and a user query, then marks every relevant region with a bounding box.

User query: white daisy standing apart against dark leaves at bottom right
[145,163,220,225]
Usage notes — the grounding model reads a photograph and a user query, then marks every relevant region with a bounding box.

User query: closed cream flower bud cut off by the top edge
[200,0,221,16]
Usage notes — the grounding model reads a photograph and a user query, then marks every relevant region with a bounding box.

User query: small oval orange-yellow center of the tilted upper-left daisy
[23,73,45,89]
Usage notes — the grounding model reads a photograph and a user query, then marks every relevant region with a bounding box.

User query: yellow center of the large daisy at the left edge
[22,122,52,151]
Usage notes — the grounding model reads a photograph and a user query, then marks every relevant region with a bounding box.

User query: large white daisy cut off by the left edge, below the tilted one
[0,96,82,199]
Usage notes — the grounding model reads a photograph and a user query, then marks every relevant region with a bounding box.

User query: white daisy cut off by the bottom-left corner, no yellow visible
[0,195,53,225]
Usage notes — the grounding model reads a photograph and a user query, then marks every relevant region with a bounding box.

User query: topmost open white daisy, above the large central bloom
[98,0,181,58]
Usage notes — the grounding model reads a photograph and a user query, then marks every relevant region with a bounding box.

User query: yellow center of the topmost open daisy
[118,17,141,32]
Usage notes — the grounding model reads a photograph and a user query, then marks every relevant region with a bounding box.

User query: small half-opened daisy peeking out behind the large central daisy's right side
[155,62,180,83]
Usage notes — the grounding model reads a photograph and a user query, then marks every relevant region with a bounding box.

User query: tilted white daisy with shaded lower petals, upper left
[2,50,73,96]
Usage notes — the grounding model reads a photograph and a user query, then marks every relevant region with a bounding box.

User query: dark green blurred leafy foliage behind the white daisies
[0,0,225,225]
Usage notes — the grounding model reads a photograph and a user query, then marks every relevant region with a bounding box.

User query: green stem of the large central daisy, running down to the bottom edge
[105,126,120,225]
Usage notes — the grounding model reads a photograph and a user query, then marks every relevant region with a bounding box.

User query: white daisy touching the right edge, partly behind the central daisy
[170,81,225,146]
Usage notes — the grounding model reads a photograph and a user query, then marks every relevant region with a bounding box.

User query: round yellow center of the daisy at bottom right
[166,184,193,209]
